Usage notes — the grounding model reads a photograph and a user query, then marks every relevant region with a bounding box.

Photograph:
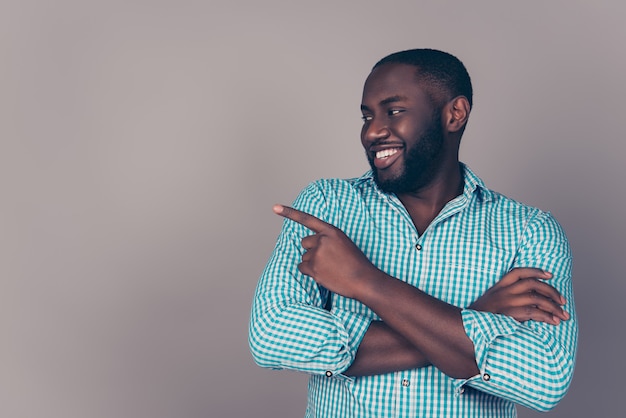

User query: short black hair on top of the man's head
[372,48,472,108]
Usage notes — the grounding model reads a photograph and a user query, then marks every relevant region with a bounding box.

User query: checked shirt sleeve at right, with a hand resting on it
[456,213,578,411]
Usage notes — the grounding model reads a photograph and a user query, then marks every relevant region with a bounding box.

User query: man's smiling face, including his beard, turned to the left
[361,64,444,194]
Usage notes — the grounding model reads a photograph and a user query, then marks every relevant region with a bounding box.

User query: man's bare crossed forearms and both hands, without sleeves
[274,205,569,379]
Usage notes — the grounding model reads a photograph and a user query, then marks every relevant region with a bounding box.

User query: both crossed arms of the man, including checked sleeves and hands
[250,200,577,411]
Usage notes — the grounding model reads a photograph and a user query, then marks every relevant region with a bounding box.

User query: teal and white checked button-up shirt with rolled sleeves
[249,166,578,418]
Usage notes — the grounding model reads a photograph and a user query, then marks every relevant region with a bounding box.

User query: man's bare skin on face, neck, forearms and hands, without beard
[274,64,569,379]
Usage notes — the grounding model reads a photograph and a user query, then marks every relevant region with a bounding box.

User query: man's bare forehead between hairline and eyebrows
[363,63,427,104]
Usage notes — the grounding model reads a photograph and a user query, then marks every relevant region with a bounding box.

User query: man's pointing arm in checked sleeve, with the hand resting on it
[274,205,577,410]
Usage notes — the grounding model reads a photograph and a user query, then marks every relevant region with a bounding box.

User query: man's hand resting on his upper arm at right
[469,268,570,325]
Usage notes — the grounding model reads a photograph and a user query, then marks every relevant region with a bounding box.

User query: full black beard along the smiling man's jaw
[368,114,444,194]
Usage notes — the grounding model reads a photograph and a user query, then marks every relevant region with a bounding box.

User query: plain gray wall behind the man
[0,0,626,418]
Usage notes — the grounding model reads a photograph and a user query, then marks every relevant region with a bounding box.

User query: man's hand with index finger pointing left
[273,205,381,298]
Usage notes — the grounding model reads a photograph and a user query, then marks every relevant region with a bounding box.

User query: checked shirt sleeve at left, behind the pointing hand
[248,184,371,377]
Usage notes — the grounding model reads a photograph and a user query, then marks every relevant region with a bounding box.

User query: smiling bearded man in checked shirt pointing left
[250,49,577,418]
